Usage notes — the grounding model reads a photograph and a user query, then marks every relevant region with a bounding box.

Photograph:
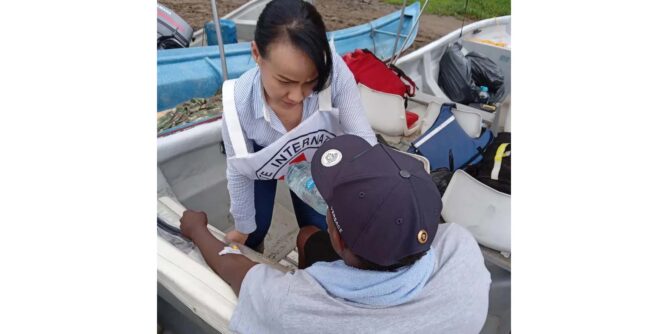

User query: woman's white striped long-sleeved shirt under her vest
[223,53,376,233]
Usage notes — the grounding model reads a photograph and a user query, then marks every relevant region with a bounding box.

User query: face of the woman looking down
[251,42,318,109]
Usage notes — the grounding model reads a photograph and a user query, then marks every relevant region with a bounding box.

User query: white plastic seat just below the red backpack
[357,83,422,137]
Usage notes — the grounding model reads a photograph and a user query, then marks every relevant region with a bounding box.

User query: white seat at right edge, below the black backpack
[441,170,510,253]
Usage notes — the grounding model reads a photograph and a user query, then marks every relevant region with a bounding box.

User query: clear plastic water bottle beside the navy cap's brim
[285,161,327,215]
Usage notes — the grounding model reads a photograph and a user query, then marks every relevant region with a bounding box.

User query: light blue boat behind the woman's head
[157,2,420,112]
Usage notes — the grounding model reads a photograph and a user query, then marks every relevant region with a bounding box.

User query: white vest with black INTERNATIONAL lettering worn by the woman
[223,80,343,180]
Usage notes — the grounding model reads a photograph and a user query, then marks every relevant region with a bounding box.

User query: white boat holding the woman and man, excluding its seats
[157,81,510,333]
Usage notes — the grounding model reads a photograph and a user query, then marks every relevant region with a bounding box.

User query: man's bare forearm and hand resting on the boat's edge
[181,210,257,296]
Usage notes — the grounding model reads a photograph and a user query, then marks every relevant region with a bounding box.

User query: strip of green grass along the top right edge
[384,0,510,20]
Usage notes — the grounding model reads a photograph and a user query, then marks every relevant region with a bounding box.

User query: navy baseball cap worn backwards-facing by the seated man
[311,135,442,266]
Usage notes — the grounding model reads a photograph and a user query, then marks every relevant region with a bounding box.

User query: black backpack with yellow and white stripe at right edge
[465,132,510,195]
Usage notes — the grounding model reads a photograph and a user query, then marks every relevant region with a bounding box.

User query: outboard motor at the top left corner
[158,4,193,49]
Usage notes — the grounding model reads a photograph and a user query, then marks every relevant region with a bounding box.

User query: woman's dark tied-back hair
[255,0,332,92]
